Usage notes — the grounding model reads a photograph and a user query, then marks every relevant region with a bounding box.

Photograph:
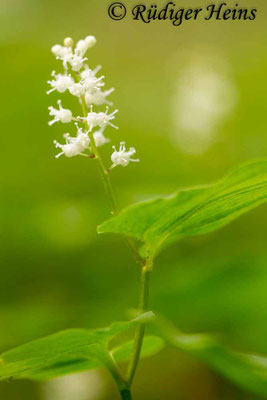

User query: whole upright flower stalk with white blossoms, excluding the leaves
[47,36,153,400]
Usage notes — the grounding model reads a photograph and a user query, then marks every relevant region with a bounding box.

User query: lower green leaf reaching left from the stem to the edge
[0,312,153,380]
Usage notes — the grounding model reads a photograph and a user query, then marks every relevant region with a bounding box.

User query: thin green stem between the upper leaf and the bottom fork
[127,248,153,387]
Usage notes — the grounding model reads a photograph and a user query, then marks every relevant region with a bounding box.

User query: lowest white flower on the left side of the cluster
[54,124,90,158]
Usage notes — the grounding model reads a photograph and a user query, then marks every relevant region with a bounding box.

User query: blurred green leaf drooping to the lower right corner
[156,320,267,396]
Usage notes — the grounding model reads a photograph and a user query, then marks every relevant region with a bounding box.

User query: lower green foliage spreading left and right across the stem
[0,312,267,395]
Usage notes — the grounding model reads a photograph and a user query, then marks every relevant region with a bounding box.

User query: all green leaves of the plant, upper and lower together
[0,160,267,396]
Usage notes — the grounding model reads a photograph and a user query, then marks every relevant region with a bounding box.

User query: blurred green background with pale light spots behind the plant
[0,0,267,400]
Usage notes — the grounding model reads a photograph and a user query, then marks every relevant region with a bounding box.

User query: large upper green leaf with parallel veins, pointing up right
[98,159,267,253]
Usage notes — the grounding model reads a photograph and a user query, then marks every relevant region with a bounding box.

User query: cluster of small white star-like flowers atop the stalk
[47,36,139,169]
